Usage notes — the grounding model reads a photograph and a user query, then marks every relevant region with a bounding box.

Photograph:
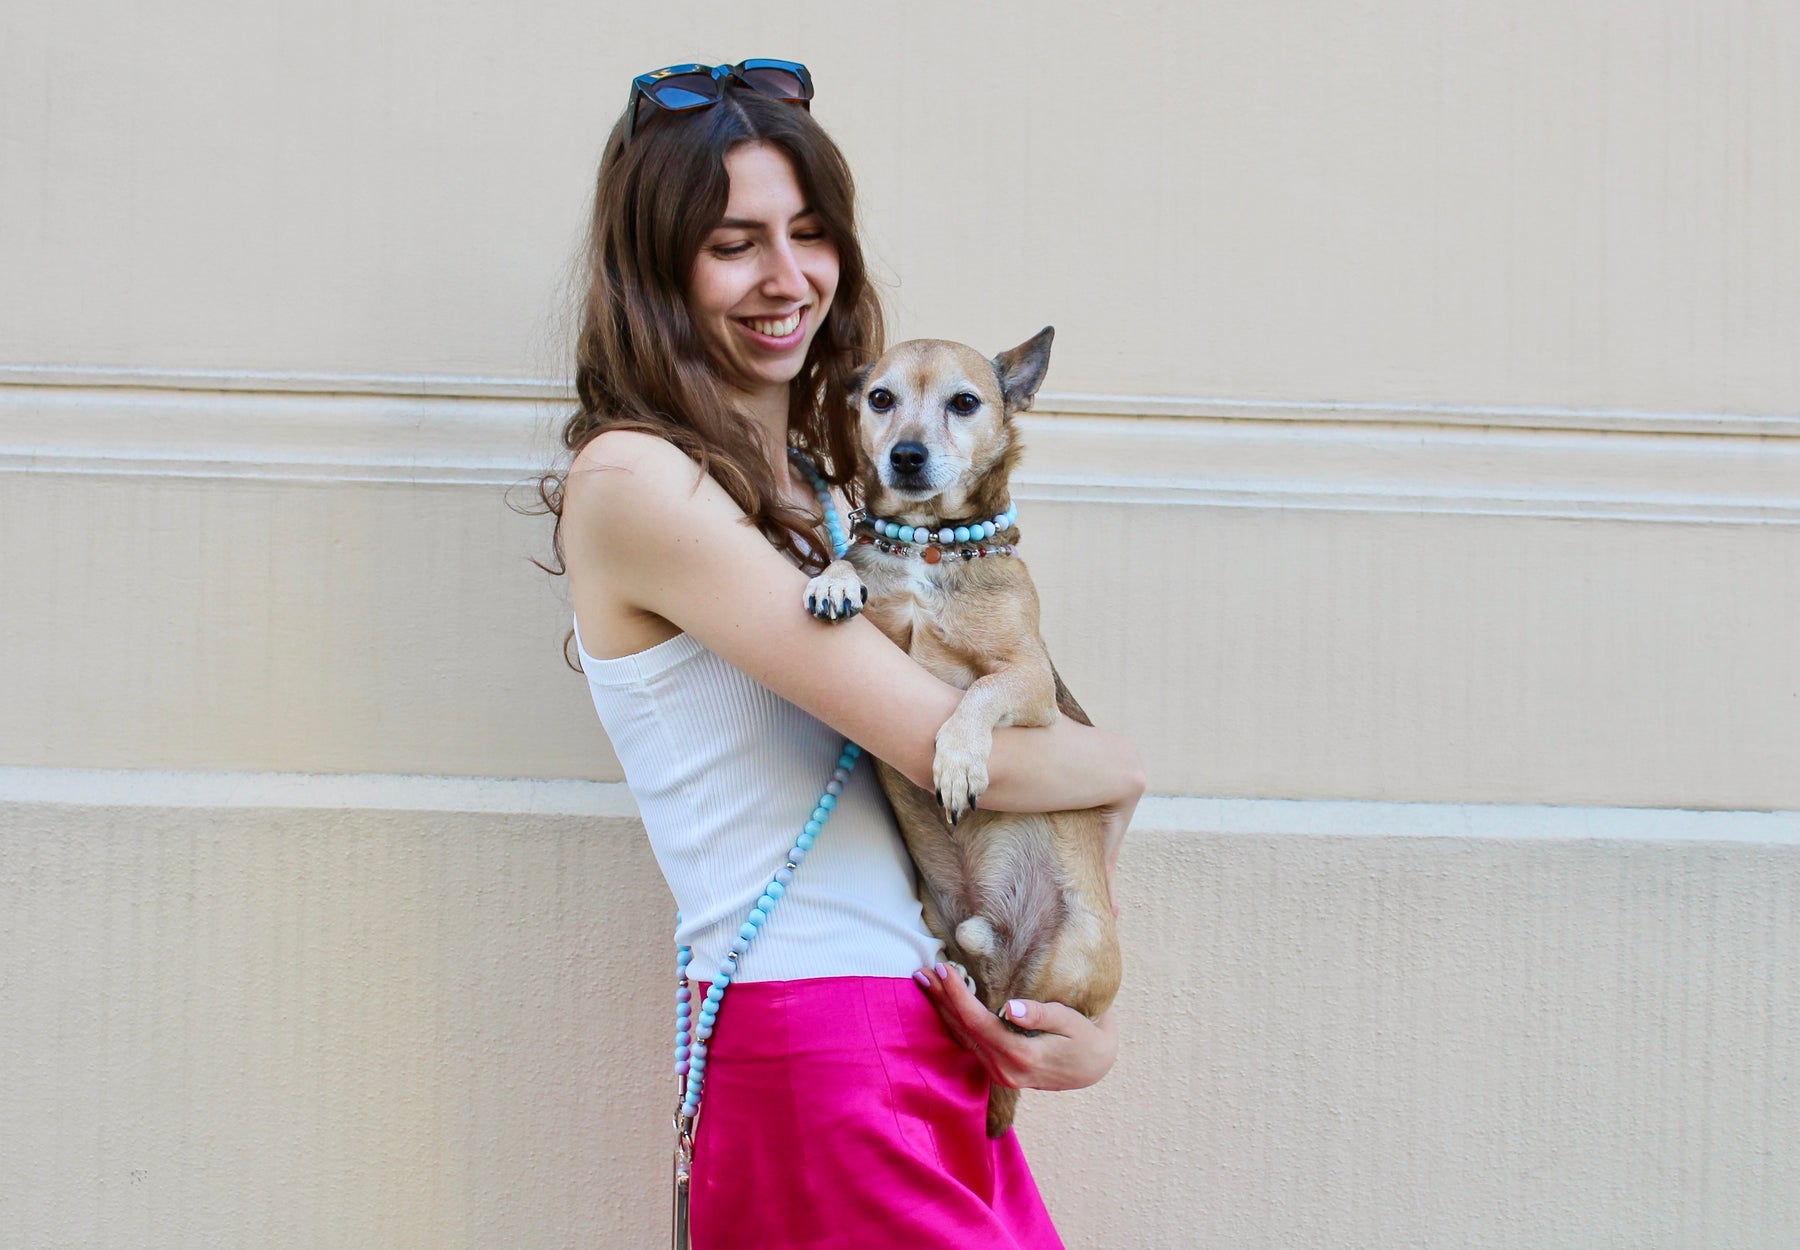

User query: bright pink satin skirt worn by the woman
[691,976,1062,1250]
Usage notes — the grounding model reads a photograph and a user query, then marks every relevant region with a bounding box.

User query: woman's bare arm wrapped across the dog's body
[563,430,1143,811]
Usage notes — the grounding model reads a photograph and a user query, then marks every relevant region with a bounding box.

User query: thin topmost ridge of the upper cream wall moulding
[0,364,1800,438]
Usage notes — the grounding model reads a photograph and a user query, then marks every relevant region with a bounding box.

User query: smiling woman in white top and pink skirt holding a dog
[549,61,1143,1250]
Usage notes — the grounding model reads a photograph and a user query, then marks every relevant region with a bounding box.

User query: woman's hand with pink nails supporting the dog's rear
[913,965,1129,1090]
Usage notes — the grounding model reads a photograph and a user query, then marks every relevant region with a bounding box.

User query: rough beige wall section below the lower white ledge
[0,792,1800,1250]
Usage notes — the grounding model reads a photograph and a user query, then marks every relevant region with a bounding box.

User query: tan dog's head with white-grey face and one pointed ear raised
[857,326,1055,519]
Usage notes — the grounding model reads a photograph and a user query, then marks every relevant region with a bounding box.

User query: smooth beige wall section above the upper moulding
[0,0,1800,421]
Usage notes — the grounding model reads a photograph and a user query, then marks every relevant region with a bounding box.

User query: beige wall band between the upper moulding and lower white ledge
[0,410,1800,809]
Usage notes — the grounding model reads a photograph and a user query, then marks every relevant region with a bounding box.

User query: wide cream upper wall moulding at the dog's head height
[10,385,1800,524]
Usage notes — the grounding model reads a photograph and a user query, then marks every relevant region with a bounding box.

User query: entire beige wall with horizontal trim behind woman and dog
[0,0,1800,1250]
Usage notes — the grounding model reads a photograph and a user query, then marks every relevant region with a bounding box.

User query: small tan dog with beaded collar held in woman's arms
[806,328,1120,1137]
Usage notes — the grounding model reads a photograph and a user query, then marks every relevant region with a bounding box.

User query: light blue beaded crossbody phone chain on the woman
[671,448,862,1250]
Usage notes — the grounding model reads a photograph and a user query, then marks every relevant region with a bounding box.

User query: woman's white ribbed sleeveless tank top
[576,630,943,982]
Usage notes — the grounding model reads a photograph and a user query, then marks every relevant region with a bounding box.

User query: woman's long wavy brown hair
[538,90,882,657]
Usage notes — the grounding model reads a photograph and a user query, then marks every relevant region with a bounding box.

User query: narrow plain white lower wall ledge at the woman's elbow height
[0,767,1800,847]
